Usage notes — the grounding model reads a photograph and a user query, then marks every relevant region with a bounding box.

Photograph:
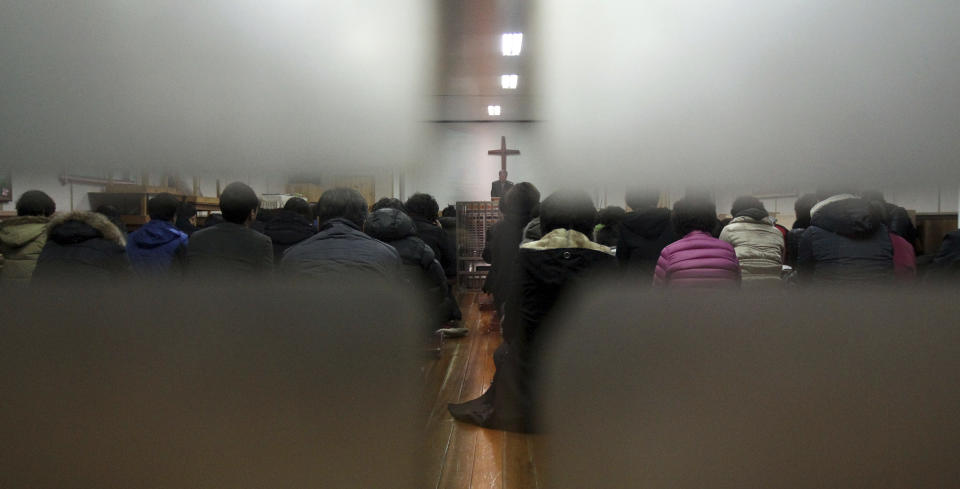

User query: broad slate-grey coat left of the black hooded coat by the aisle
[280,217,400,280]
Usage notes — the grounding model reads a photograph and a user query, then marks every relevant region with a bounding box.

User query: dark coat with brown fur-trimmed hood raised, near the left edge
[32,211,130,284]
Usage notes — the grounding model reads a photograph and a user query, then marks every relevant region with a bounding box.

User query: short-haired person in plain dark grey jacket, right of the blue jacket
[187,182,273,279]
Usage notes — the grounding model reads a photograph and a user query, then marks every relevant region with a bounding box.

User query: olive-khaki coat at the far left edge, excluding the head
[0,216,50,284]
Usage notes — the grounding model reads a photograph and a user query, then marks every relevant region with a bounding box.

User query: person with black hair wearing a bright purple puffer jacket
[653,197,744,288]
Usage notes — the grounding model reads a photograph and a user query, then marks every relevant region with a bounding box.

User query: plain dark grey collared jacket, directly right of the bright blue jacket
[187,222,273,279]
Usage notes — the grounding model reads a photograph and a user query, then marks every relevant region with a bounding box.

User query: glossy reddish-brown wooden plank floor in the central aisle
[424,292,541,489]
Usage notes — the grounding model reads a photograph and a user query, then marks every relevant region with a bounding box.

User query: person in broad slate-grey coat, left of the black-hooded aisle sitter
[280,188,401,280]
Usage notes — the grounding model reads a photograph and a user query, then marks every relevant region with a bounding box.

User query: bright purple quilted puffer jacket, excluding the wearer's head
[653,231,740,287]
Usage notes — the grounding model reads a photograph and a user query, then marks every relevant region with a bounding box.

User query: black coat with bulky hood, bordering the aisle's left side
[363,209,454,326]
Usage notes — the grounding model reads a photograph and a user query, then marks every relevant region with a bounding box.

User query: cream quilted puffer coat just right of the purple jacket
[720,209,785,281]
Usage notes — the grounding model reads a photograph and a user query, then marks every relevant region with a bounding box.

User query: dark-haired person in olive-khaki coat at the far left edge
[0,190,57,285]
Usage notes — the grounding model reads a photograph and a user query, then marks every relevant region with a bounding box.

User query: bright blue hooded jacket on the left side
[127,219,187,277]
